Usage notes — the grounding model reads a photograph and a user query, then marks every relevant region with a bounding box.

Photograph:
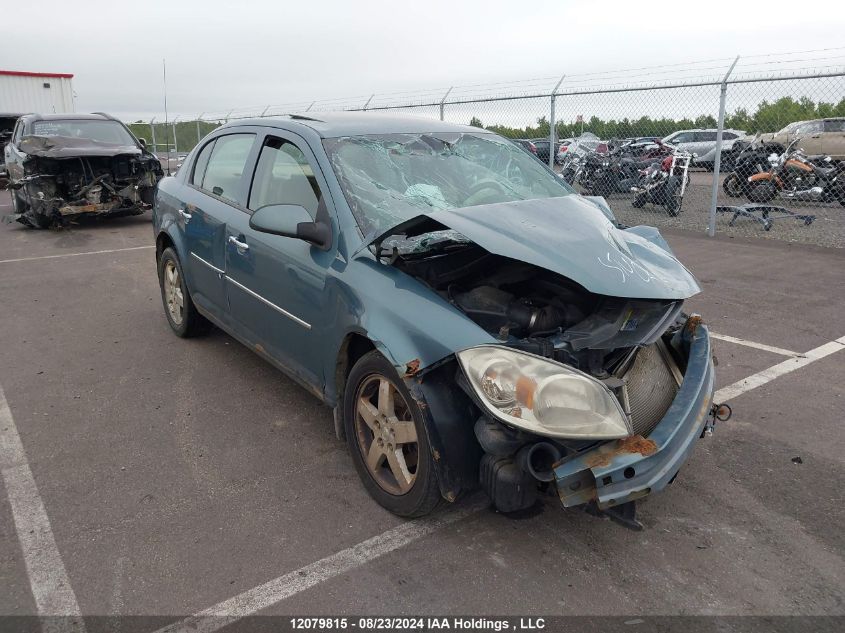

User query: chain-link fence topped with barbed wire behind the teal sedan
[125,47,845,247]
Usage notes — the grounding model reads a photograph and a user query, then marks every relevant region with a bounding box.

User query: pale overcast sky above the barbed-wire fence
[6,0,845,120]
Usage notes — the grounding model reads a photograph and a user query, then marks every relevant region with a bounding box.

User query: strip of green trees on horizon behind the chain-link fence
[470,97,845,139]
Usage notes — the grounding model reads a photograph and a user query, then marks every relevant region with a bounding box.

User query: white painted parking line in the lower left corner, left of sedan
[0,386,85,633]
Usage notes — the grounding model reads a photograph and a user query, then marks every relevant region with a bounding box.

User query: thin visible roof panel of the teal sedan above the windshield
[218,112,484,138]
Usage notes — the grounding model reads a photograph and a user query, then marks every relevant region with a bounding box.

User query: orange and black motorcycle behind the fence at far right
[746,139,845,206]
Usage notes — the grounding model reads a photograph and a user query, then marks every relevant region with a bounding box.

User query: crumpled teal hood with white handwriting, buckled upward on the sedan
[364,195,701,300]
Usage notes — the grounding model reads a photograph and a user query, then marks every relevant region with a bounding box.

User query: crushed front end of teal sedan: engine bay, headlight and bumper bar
[386,233,714,528]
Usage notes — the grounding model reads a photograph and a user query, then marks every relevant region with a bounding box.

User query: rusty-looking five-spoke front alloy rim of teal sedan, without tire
[355,374,419,495]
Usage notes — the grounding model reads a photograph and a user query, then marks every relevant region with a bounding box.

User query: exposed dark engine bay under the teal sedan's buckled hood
[394,244,683,379]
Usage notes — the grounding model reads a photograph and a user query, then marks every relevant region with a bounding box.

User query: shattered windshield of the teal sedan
[323,132,572,249]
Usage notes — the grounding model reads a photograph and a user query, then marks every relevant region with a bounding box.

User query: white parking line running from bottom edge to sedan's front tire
[156,501,489,633]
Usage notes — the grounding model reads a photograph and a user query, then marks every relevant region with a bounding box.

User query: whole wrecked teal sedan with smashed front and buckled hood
[153,113,716,528]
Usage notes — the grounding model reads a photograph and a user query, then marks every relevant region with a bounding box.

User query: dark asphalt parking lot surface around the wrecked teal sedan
[0,193,845,631]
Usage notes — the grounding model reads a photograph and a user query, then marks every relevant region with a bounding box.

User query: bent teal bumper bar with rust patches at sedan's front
[554,324,714,510]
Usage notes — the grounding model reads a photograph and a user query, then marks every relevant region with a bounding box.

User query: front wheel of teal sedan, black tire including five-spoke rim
[343,351,442,518]
